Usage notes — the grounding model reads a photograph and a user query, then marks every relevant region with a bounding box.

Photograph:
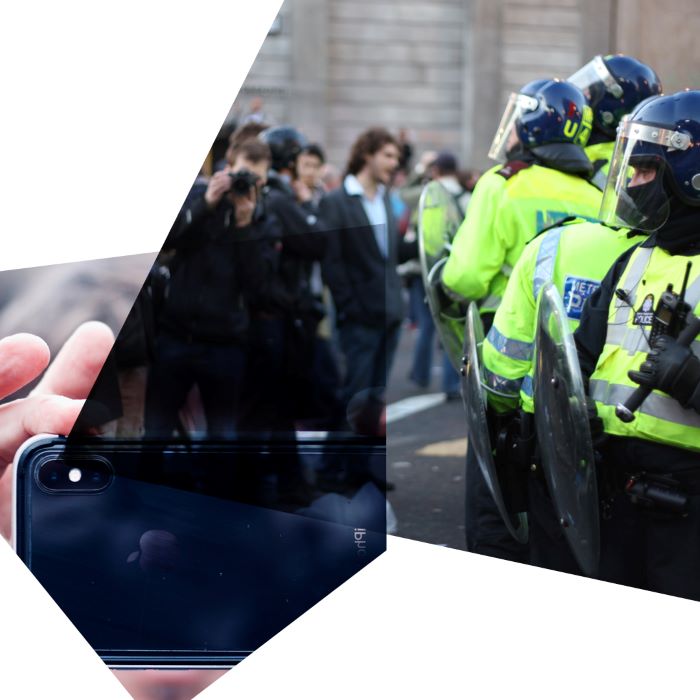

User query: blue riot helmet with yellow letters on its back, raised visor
[489,78,591,163]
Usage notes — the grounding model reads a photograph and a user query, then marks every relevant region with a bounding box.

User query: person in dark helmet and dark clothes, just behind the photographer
[235,126,327,432]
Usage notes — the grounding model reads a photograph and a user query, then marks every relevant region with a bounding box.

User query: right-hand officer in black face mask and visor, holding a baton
[575,91,700,599]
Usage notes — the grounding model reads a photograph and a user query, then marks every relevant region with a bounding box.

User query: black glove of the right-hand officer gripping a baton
[627,335,700,412]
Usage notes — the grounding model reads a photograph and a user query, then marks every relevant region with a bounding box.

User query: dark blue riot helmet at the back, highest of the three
[568,54,661,141]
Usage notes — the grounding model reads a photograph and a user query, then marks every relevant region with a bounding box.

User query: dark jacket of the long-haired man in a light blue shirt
[320,185,417,327]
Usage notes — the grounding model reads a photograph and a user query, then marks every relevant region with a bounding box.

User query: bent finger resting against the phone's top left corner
[0,394,84,476]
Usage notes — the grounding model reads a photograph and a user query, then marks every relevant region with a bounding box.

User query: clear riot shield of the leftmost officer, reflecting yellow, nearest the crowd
[418,181,464,371]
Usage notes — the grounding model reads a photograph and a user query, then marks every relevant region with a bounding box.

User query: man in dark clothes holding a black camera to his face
[144,139,278,437]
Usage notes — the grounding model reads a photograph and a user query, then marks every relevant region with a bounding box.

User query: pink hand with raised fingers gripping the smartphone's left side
[0,322,114,538]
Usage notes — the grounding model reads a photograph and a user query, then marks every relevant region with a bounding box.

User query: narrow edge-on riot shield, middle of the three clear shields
[460,302,528,544]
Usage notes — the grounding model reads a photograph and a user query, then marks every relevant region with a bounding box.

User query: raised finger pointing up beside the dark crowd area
[32,321,114,399]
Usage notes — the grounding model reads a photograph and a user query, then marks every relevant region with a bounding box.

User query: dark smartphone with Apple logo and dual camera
[13,436,386,668]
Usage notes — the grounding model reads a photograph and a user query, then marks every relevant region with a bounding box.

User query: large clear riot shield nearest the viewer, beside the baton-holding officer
[534,283,600,576]
